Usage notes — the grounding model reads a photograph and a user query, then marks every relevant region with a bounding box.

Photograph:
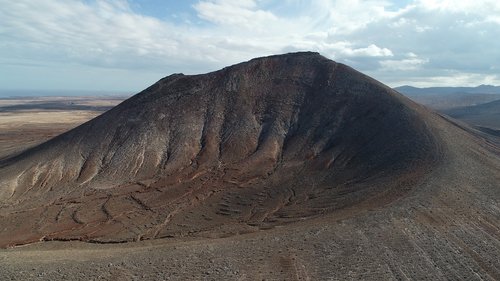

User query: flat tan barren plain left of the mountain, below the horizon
[0,97,125,159]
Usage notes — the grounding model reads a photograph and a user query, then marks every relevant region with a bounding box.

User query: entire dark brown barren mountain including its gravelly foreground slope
[0,53,500,280]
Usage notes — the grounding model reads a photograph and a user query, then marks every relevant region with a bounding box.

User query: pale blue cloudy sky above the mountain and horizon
[0,0,500,92]
